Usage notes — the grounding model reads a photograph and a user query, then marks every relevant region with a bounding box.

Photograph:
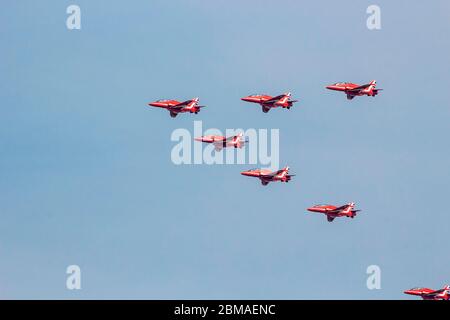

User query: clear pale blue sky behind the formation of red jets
[0,0,450,299]
